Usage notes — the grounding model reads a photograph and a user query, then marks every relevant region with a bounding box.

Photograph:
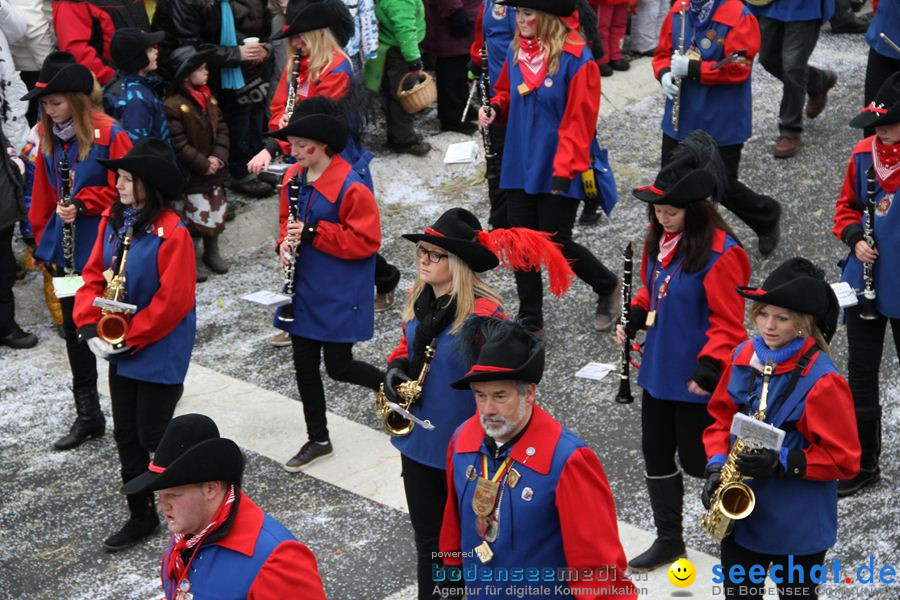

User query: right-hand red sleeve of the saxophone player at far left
[125,227,197,349]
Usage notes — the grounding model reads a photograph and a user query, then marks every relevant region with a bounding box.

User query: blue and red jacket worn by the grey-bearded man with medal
[440,404,637,600]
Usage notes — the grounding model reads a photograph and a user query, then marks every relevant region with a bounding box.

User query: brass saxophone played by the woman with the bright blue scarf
[700,360,775,541]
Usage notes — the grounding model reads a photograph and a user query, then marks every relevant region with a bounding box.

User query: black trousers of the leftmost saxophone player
[109,364,184,483]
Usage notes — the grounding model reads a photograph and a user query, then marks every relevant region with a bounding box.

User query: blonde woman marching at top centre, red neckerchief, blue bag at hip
[479,0,618,334]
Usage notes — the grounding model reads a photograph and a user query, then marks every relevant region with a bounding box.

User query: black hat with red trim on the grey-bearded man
[450,317,544,390]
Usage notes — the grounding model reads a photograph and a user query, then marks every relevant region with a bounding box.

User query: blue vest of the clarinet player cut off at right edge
[840,137,900,319]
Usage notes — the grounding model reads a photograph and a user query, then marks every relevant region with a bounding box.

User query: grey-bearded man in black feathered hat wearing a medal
[433,318,637,600]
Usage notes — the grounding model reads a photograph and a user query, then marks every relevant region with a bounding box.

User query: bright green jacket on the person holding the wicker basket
[365,0,425,91]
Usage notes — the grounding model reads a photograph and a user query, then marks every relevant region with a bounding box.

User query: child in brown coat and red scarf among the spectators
[166,46,229,281]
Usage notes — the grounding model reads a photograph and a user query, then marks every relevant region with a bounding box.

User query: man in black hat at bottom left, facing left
[122,414,325,600]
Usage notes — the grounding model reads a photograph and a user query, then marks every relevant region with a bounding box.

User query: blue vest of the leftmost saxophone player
[103,221,197,384]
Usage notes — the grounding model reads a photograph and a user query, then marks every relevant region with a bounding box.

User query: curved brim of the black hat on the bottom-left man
[121,438,244,495]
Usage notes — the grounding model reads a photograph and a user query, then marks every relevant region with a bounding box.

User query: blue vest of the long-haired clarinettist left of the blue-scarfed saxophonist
[638,235,738,404]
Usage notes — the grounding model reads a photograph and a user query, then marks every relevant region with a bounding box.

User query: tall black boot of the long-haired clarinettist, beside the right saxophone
[628,471,687,571]
